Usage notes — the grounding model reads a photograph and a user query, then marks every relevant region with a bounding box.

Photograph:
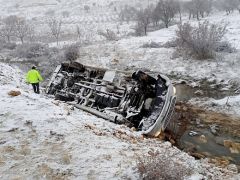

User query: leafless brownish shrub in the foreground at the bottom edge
[137,150,191,180]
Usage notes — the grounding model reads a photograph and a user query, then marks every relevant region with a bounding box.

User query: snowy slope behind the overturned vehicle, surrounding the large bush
[79,12,240,84]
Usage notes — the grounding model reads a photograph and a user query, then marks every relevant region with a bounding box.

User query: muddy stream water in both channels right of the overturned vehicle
[171,84,240,170]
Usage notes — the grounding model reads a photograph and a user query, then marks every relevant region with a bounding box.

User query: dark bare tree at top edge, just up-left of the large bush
[155,0,178,28]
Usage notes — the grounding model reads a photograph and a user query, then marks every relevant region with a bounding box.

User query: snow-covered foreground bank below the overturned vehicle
[0,63,240,179]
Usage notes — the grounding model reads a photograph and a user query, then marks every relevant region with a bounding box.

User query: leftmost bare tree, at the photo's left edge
[0,16,18,42]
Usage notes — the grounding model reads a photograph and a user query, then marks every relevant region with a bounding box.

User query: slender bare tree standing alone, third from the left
[48,18,62,45]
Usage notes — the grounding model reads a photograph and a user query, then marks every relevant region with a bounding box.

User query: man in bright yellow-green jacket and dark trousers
[27,66,43,94]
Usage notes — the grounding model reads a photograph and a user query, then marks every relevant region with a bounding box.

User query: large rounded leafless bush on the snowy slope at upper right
[176,21,226,59]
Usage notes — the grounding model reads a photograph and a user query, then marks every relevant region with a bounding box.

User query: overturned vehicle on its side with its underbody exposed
[46,62,176,136]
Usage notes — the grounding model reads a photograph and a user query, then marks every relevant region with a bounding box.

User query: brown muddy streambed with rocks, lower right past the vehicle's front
[164,103,240,170]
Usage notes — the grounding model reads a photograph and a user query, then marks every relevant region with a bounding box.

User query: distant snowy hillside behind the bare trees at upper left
[0,0,143,41]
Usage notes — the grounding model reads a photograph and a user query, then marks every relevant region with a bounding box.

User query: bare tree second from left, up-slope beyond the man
[14,18,33,44]
